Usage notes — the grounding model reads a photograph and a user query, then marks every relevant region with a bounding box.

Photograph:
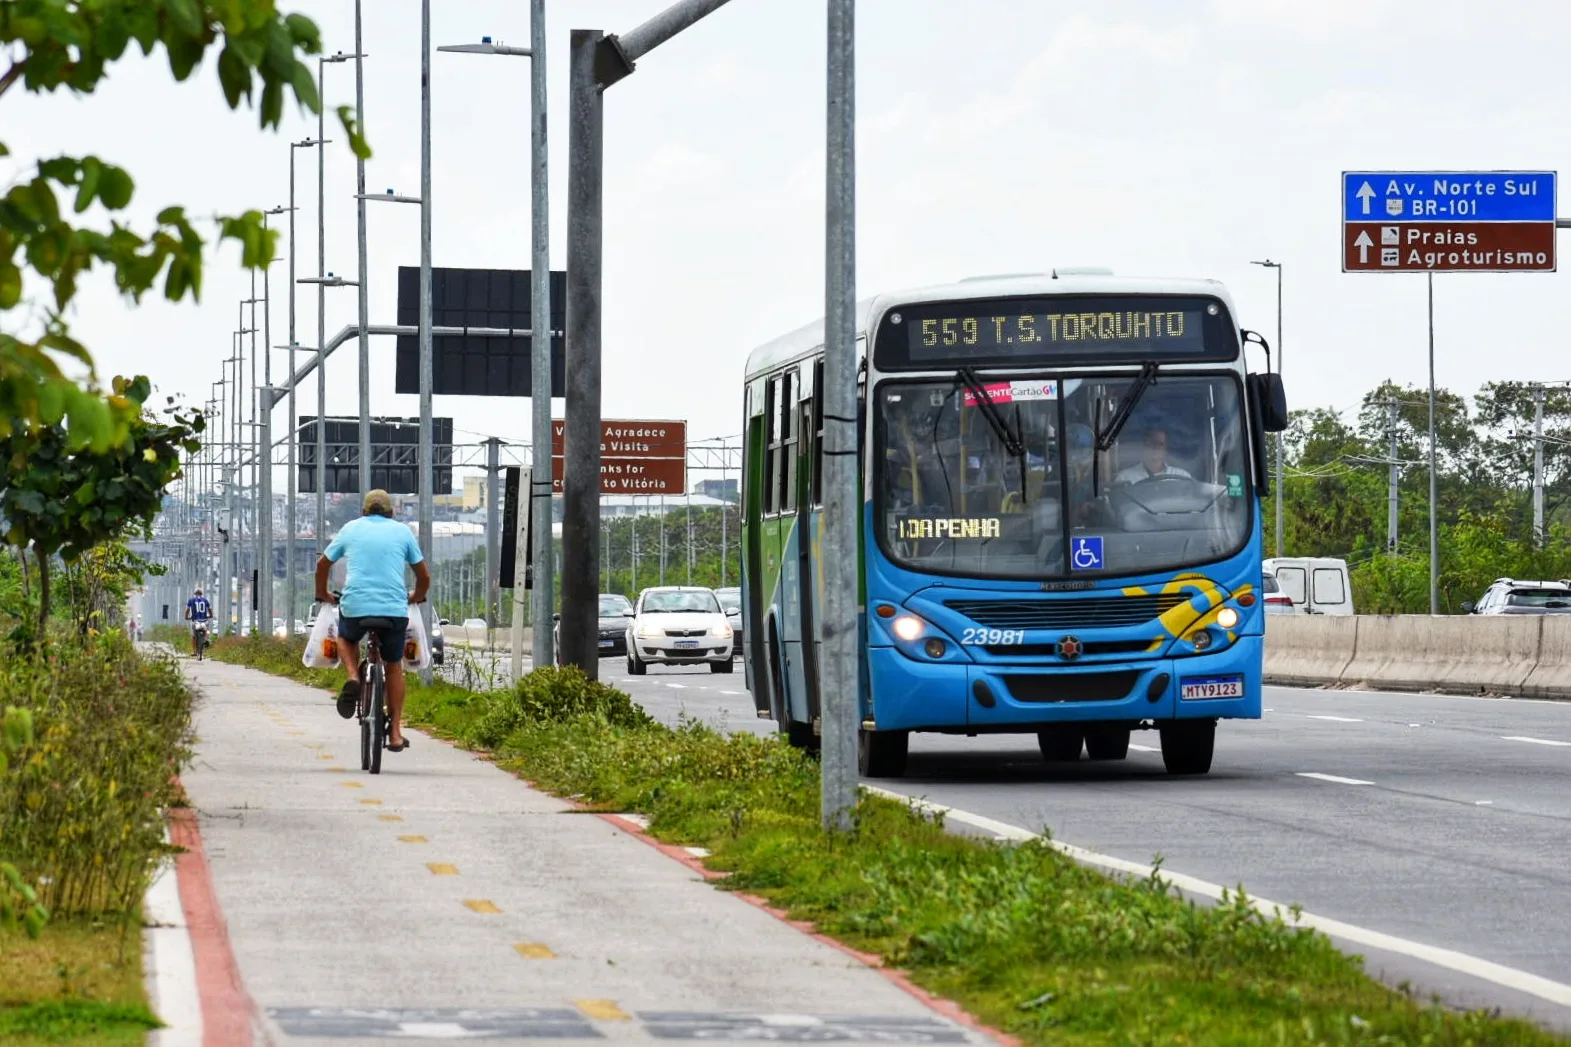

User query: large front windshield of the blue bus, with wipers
[873,369,1254,580]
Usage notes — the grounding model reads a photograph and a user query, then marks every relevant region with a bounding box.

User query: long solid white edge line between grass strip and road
[862,784,1571,1006]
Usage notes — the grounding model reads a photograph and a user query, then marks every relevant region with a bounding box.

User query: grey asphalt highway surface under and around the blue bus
[490,657,1571,1031]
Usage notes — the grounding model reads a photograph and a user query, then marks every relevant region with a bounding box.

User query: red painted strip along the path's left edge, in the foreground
[168,806,272,1047]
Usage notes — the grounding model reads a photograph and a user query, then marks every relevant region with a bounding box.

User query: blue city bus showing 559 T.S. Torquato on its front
[742,269,1287,777]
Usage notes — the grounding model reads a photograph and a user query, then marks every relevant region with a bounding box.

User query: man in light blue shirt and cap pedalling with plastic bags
[316,489,430,753]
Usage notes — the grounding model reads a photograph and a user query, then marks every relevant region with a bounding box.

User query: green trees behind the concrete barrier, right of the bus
[1265,382,1571,613]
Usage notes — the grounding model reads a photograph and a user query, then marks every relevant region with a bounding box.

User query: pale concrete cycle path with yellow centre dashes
[165,662,991,1047]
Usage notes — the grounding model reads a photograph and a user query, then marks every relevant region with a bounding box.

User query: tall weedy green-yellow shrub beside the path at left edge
[0,632,193,915]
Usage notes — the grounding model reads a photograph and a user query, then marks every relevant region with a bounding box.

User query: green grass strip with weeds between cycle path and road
[214,641,1571,1047]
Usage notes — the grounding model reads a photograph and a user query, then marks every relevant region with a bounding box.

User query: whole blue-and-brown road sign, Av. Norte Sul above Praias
[1342,171,1557,272]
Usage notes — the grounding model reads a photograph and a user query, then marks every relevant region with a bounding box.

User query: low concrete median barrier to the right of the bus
[1265,615,1571,698]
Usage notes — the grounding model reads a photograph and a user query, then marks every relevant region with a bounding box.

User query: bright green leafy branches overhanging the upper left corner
[0,0,369,451]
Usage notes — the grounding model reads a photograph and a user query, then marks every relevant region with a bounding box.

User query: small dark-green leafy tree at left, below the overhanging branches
[0,376,206,629]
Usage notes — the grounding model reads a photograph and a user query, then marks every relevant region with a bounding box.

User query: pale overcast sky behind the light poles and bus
[5,0,1571,483]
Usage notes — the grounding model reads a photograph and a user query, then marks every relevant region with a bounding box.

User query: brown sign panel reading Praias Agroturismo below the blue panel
[1342,222,1555,272]
